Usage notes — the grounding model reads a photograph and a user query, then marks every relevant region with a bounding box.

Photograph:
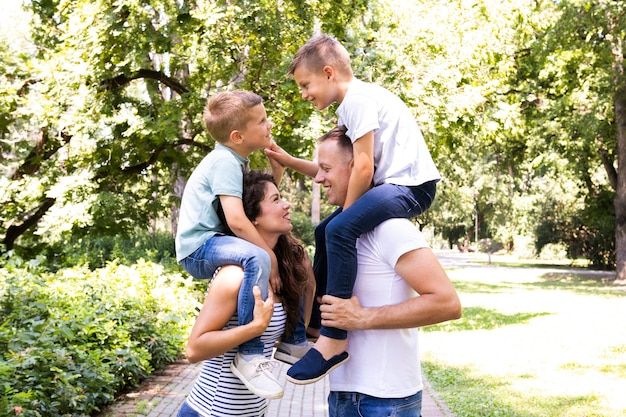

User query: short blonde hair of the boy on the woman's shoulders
[203,91,263,143]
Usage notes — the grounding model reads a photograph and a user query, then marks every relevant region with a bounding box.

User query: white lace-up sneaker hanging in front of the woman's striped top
[230,353,284,400]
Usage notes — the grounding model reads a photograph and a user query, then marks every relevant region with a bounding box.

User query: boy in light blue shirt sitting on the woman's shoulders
[176,91,283,398]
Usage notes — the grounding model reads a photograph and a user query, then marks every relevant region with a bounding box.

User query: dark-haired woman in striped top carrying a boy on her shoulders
[178,171,315,417]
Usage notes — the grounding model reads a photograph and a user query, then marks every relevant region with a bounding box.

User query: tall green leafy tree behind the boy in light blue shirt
[0,0,367,252]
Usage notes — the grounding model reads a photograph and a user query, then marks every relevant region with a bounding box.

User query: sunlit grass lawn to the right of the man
[420,252,626,417]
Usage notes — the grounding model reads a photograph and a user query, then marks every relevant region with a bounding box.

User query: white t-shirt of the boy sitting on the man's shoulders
[336,78,441,186]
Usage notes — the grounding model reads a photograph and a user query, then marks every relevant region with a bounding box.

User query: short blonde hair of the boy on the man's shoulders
[287,34,352,77]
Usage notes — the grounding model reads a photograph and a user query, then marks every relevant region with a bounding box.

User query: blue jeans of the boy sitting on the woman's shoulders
[181,235,271,355]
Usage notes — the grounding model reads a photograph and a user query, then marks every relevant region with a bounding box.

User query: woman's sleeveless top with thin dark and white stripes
[186,303,287,417]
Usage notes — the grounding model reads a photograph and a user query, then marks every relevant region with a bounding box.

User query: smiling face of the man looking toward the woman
[315,139,353,206]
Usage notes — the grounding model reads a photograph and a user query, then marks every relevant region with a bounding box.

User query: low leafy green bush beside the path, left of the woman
[0,257,197,416]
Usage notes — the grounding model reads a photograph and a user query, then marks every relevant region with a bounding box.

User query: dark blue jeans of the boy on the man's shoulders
[313,181,437,339]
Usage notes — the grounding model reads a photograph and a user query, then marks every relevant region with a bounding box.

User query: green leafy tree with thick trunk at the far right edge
[517,0,626,280]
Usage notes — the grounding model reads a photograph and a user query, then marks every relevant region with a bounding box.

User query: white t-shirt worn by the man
[329,219,428,398]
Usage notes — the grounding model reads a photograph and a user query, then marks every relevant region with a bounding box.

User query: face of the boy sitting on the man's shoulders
[293,65,337,110]
